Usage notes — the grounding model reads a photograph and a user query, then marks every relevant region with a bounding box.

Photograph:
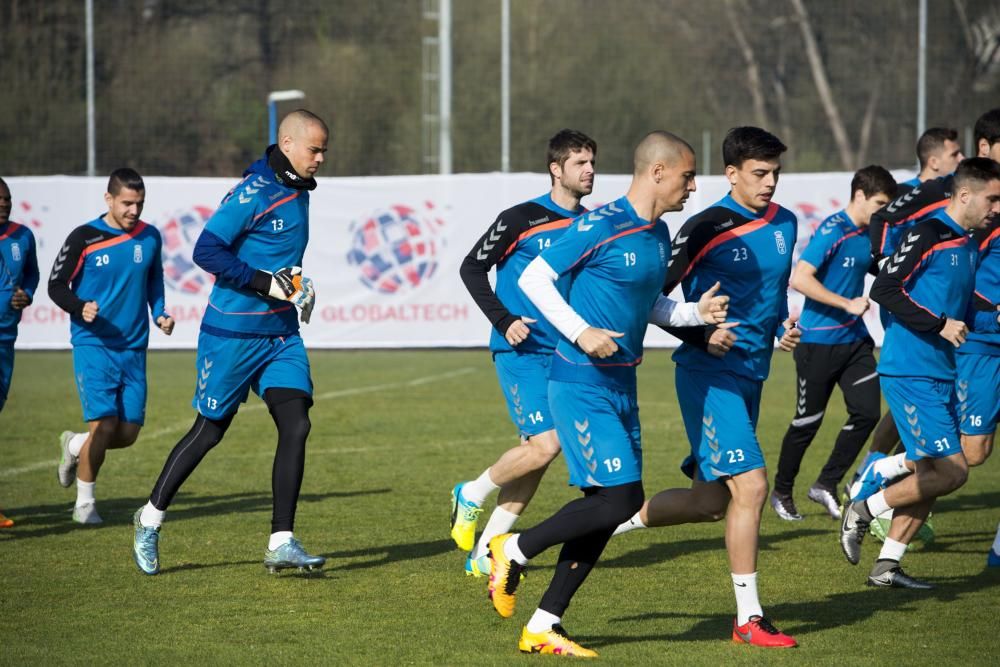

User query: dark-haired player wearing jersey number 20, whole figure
[49,167,174,525]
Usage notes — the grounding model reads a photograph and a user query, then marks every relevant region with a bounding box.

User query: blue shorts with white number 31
[880,375,962,461]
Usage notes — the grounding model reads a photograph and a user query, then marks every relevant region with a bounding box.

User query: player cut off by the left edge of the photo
[0,178,38,528]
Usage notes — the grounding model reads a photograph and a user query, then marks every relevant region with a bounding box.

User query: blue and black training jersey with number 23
[664,195,798,380]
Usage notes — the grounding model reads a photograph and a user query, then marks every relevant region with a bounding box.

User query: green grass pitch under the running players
[0,351,1000,665]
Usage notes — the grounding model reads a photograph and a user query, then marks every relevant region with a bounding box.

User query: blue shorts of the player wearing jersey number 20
[73,345,146,426]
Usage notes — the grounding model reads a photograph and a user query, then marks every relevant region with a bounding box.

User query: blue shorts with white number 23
[674,366,764,482]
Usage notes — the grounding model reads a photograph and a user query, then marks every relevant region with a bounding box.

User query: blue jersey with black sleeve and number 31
[871,211,978,382]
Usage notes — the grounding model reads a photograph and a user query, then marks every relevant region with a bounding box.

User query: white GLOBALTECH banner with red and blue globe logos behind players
[7,172,909,349]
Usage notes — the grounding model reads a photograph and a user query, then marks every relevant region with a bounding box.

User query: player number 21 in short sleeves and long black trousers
[771,165,896,521]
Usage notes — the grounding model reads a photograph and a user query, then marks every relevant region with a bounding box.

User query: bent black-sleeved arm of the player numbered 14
[458,211,527,336]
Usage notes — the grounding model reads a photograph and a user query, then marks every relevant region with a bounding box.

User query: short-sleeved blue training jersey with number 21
[799,211,872,345]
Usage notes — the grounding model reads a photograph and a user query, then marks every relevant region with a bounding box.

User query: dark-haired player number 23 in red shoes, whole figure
[616,127,800,647]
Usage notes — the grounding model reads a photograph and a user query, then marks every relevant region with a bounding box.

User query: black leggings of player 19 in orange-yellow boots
[517,482,644,616]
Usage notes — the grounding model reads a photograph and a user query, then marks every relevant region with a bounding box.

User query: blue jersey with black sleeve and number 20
[49,217,167,349]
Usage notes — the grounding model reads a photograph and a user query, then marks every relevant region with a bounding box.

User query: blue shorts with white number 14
[493,352,555,439]
